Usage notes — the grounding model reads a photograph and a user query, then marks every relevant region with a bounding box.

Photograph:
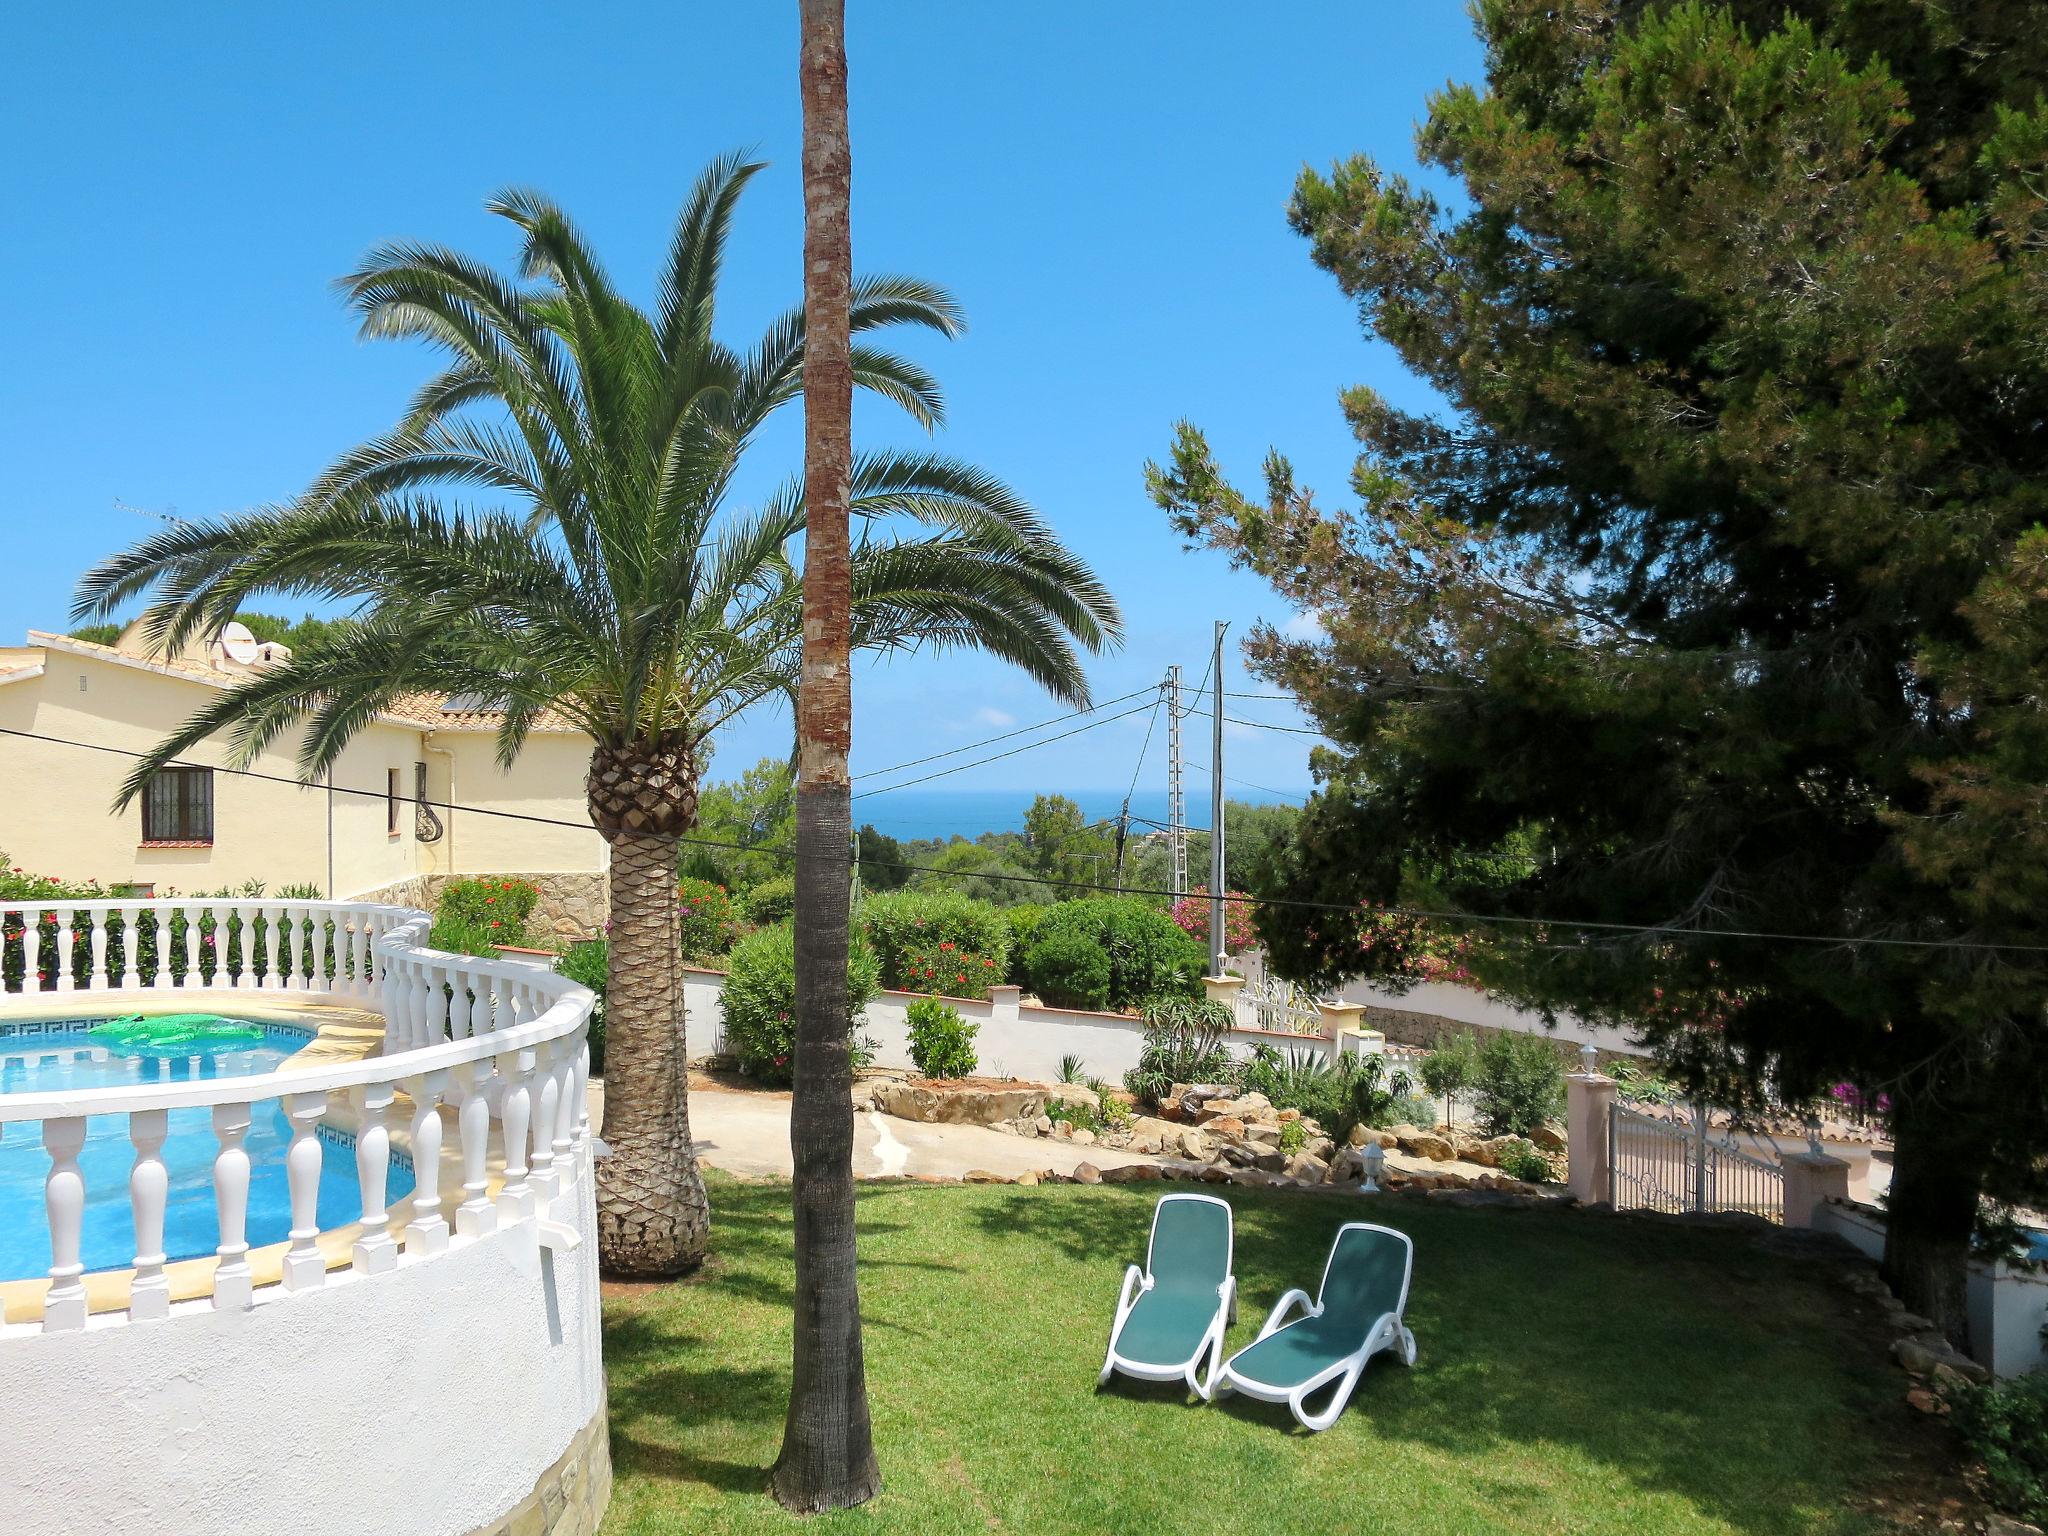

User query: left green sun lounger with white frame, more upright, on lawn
[1096,1194,1237,1401]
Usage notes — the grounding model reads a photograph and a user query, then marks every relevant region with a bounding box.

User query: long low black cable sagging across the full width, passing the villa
[0,711,2048,954]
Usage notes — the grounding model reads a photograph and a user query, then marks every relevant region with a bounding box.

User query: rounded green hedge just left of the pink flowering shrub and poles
[1024,897,1208,1010]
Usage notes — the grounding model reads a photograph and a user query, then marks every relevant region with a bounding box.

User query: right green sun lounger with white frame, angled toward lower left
[1219,1221,1415,1430]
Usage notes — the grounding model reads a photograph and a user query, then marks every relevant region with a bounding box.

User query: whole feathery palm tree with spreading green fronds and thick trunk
[74,156,1120,1276]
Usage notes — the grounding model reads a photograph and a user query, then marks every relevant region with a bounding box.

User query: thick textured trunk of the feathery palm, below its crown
[596,829,711,1276]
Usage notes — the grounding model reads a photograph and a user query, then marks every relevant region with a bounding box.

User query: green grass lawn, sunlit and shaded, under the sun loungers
[604,1182,1946,1536]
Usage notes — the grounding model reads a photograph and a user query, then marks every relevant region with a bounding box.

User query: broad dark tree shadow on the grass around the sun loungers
[975,1188,1937,1534]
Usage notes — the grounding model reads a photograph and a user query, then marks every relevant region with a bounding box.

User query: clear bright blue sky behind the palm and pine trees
[0,0,1479,795]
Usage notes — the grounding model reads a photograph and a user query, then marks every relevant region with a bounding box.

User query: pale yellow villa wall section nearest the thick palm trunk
[436,731,606,874]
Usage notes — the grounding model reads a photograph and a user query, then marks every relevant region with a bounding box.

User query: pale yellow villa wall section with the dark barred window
[0,649,432,893]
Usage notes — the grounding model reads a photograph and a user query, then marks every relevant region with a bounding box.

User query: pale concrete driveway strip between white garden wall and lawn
[590,1079,1157,1180]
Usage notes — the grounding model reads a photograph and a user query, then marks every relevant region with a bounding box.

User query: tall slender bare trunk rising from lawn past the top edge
[770,0,881,1511]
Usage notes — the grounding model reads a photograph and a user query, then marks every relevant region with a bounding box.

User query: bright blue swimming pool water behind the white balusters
[0,1020,412,1280]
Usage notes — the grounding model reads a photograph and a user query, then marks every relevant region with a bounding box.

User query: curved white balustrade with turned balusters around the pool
[0,899,592,1331]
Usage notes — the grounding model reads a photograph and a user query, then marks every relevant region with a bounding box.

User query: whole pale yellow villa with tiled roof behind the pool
[0,625,604,936]
